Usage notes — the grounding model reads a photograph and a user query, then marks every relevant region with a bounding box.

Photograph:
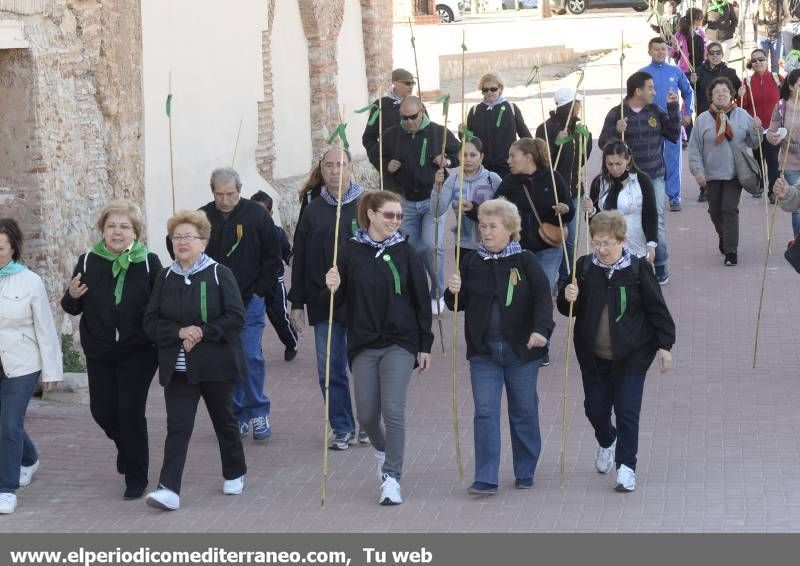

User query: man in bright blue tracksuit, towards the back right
[640,36,694,214]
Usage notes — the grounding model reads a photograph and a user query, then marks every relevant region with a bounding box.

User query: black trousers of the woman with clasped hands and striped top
[158,373,247,493]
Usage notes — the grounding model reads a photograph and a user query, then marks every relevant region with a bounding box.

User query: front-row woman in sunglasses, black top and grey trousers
[325,191,433,505]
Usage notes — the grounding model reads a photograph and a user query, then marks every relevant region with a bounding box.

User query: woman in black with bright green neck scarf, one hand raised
[61,200,161,500]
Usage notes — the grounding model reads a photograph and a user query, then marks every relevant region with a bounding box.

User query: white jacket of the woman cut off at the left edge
[0,269,64,381]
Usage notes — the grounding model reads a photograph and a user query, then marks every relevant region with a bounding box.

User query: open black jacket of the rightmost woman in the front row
[558,255,675,378]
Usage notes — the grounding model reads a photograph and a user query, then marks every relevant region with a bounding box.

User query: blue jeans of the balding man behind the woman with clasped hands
[233,295,269,423]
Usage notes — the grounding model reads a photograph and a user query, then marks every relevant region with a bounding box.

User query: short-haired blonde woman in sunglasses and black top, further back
[467,73,532,177]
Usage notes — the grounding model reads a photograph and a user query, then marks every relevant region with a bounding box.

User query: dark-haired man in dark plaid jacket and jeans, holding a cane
[597,71,681,285]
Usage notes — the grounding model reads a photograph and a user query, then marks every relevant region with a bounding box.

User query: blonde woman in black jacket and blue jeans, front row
[445,199,553,495]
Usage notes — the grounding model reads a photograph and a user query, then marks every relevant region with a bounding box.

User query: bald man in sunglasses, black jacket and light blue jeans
[369,96,460,313]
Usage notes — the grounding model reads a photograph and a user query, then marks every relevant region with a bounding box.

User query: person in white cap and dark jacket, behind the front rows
[536,87,592,292]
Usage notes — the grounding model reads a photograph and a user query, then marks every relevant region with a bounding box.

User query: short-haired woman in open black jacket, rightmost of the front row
[558,210,675,492]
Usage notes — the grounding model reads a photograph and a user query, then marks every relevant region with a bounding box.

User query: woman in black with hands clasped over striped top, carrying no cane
[144,210,247,510]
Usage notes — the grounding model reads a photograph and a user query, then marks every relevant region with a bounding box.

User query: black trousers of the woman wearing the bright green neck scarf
[86,346,158,488]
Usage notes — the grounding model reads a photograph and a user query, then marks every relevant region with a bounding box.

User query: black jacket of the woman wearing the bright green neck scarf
[61,252,161,359]
